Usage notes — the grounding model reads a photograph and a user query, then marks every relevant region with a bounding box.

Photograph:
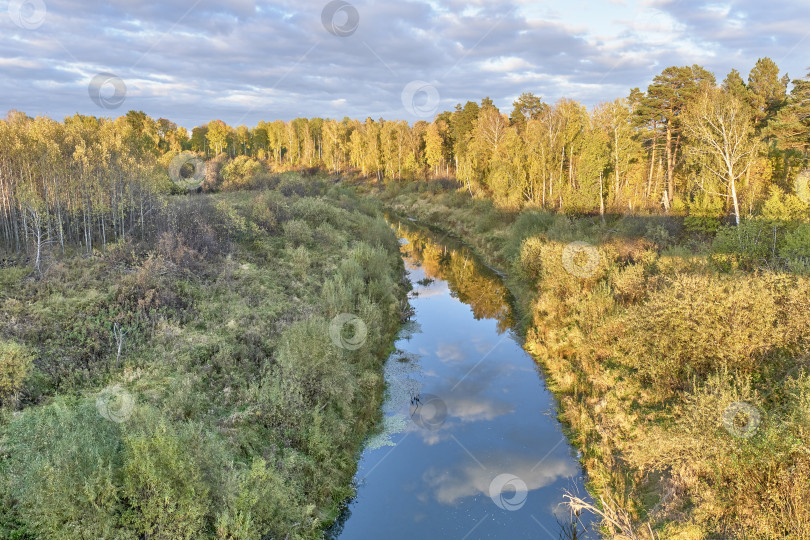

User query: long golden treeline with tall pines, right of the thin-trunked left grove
[188,58,810,220]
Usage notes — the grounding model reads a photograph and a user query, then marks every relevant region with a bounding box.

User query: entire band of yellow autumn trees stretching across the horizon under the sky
[0,58,810,262]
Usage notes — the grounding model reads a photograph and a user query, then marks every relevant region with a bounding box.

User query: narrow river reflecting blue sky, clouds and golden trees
[327,219,595,540]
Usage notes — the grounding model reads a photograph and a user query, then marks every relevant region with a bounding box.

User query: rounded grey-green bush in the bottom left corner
[2,399,127,540]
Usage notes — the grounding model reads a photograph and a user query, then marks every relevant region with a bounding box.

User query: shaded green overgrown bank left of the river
[0,174,406,539]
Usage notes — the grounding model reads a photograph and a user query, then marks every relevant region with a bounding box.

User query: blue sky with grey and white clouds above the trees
[0,0,810,128]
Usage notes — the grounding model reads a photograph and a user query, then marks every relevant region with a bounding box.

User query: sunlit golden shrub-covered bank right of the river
[360,178,810,538]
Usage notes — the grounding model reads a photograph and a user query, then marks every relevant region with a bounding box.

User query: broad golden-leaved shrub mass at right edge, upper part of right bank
[622,275,810,390]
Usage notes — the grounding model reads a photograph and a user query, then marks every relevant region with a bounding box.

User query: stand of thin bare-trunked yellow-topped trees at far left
[0,111,167,267]
